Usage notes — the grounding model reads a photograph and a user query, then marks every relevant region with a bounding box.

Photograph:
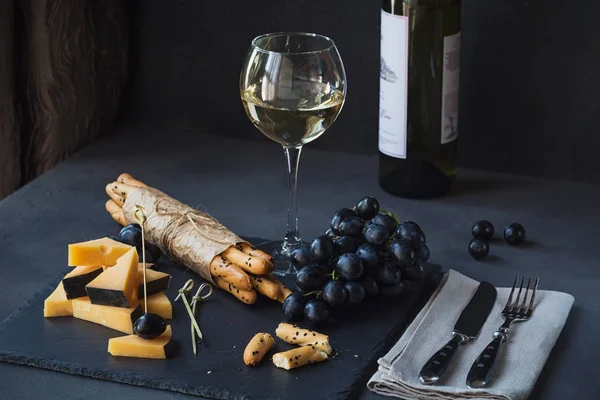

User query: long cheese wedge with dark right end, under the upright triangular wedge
[71,298,143,334]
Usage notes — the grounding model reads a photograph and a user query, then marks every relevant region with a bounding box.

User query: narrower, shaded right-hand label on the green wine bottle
[441,32,460,144]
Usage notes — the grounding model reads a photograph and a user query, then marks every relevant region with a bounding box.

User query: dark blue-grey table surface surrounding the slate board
[0,127,600,400]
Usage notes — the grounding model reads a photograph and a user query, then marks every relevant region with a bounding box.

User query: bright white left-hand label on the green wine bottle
[379,11,408,158]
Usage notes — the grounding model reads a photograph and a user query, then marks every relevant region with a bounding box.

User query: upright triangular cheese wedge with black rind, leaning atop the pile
[85,247,138,308]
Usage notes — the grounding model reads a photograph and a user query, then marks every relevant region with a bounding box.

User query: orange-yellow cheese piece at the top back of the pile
[69,238,131,267]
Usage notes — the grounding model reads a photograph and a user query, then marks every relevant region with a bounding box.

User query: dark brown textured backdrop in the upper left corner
[0,0,128,198]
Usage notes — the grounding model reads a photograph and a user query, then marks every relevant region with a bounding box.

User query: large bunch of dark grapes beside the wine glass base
[283,197,430,323]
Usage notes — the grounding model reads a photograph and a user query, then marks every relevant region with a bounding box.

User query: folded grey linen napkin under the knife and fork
[368,270,574,400]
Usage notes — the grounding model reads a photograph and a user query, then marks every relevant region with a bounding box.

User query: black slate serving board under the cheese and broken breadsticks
[0,239,439,400]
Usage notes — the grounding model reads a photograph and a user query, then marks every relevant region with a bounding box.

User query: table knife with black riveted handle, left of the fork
[419,282,496,385]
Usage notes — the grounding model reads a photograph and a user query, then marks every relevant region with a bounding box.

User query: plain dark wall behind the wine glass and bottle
[121,0,600,183]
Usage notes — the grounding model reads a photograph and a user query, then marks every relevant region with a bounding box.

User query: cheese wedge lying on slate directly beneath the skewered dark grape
[108,325,173,359]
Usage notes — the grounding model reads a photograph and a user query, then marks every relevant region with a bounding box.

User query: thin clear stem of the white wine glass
[282,146,302,255]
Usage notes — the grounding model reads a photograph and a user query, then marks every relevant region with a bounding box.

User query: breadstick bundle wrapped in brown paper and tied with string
[105,173,291,304]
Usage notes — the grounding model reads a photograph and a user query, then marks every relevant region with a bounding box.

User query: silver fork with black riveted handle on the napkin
[467,274,540,389]
